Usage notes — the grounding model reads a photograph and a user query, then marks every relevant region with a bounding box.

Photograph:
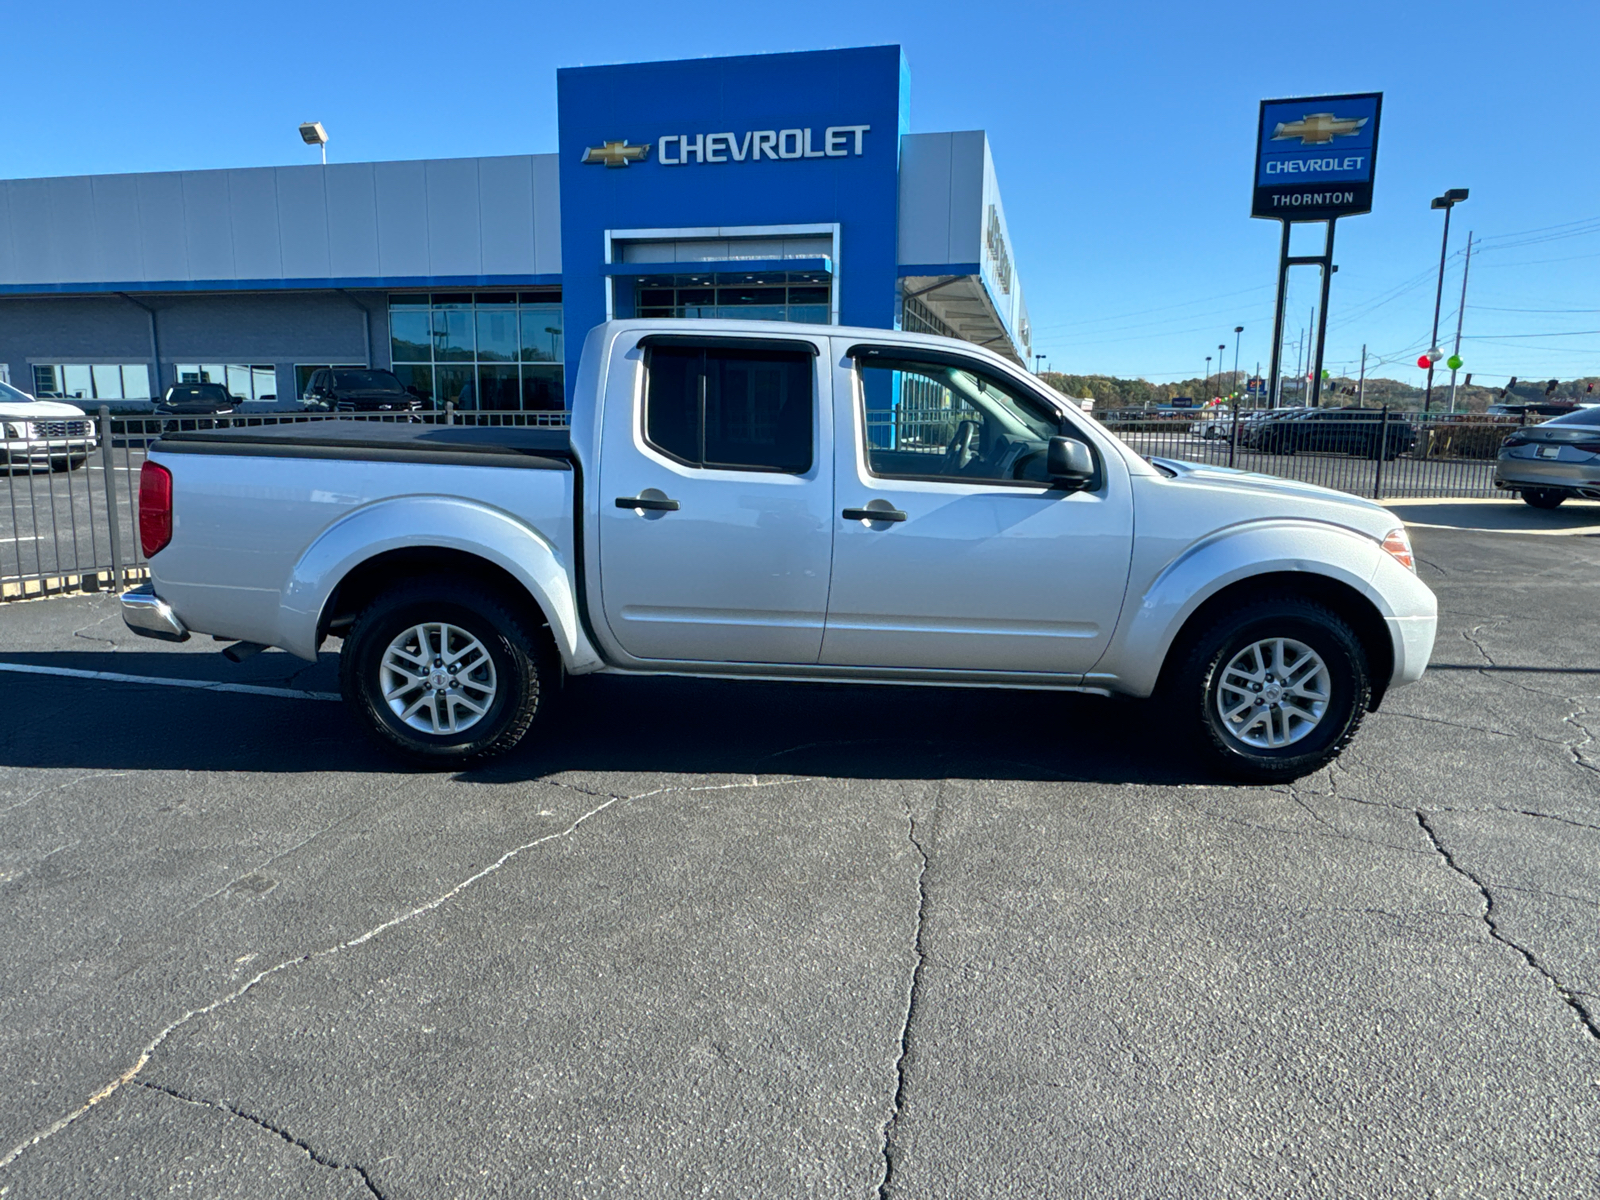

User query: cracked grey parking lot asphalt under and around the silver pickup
[0,517,1600,1200]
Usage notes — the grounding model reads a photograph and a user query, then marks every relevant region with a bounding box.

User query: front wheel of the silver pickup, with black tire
[1165,595,1373,782]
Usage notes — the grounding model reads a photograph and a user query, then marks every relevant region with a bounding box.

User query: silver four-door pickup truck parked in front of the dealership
[123,320,1435,779]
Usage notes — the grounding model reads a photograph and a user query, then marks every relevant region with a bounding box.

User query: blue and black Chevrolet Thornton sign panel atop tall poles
[1250,91,1384,221]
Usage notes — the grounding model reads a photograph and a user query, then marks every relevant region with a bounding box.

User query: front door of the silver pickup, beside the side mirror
[822,341,1133,675]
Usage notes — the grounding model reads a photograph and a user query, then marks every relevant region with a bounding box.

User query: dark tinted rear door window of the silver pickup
[645,346,816,475]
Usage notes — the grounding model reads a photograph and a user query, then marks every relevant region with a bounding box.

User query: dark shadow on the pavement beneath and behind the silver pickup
[0,651,1216,784]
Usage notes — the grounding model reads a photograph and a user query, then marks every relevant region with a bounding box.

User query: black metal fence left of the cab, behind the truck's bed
[0,406,568,611]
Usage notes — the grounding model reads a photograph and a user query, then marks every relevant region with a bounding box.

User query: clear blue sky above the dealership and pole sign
[0,0,1600,382]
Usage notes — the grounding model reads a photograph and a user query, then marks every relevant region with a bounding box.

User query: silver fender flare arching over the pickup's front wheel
[1088,518,1395,696]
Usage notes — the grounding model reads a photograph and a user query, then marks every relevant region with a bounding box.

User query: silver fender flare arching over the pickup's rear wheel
[278,496,594,667]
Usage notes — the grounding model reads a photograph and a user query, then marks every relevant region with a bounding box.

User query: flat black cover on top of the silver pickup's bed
[152,421,574,470]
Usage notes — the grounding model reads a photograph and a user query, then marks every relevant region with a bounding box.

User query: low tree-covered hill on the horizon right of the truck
[1040,371,1600,413]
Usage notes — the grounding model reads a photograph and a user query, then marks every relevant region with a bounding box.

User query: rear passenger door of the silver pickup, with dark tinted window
[598,334,834,664]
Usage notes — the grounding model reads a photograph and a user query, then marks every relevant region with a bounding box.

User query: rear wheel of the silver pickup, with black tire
[339,579,555,768]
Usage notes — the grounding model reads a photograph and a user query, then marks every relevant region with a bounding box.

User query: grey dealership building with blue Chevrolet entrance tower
[0,46,1030,410]
